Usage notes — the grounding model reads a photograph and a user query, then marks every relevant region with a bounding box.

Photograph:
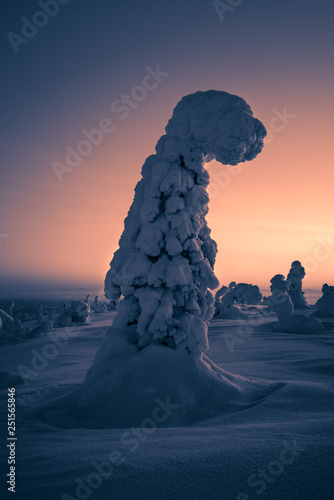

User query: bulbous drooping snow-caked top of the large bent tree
[162,90,266,166]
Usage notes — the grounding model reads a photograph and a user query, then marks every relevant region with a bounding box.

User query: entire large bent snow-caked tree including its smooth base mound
[39,90,281,427]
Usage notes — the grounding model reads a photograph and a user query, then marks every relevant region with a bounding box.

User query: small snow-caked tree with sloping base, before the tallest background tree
[269,274,325,334]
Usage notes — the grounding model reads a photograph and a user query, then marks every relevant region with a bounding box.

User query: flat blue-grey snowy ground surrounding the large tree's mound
[0,311,334,500]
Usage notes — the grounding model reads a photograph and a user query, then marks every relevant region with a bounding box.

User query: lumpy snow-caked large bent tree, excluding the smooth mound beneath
[105,90,266,351]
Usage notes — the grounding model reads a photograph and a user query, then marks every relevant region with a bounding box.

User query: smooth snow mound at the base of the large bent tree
[38,327,284,428]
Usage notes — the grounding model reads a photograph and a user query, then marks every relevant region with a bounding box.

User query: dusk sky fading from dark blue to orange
[0,0,334,292]
